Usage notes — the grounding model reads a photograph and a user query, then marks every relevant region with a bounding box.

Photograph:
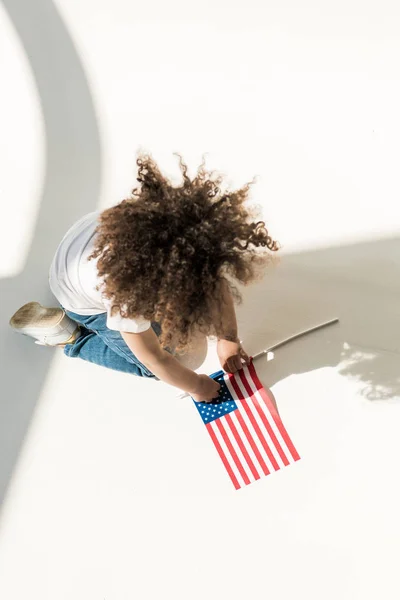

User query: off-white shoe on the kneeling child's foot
[9,302,80,346]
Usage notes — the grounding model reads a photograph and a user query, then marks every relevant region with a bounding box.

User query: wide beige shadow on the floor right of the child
[234,237,400,400]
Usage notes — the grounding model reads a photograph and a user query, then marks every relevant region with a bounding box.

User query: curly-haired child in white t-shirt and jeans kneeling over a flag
[10,153,278,401]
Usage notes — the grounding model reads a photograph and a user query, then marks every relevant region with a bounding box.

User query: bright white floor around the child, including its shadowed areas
[0,0,400,600]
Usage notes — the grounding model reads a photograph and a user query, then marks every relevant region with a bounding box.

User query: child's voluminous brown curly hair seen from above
[89,151,279,354]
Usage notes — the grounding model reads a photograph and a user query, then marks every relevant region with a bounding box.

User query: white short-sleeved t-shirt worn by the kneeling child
[49,210,151,333]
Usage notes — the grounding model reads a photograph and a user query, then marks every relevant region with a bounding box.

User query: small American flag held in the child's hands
[193,360,300,489]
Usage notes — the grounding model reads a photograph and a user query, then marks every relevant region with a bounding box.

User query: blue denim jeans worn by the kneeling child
[60,305,172,381]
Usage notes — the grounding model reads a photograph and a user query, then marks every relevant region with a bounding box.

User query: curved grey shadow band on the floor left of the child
[0,0,101,500]
